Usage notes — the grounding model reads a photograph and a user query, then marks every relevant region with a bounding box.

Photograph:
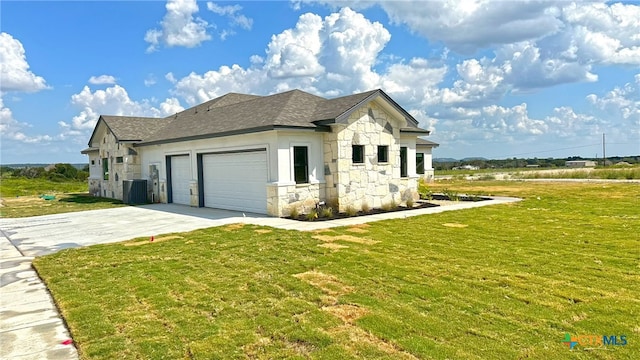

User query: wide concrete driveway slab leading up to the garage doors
[0,204,273,256]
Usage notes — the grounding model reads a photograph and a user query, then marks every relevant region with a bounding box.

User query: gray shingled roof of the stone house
[89,90,428,145]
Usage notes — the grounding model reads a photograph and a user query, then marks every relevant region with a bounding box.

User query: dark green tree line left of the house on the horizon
[0,164,89,181]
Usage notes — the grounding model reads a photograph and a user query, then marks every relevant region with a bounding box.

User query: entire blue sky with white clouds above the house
[0,0,640,164]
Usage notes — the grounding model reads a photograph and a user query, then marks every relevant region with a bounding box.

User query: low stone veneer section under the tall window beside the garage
[267,184,325,217]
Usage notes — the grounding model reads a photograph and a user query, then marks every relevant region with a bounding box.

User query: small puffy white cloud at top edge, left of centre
[144,0,211,52]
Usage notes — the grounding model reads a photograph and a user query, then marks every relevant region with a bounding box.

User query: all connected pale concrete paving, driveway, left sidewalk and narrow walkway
[0,197,520,360]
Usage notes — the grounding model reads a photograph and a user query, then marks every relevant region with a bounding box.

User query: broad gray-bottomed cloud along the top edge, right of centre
[295,0,562,54]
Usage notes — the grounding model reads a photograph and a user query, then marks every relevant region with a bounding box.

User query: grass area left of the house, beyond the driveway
[0,177,123,218]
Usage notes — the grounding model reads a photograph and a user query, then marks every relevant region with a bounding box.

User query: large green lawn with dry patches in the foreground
[34,182,640,359]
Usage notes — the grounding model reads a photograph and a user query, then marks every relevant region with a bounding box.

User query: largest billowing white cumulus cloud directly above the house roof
[166,8,396,105]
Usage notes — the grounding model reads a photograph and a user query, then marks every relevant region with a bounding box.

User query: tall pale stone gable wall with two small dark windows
[324,102,417,212]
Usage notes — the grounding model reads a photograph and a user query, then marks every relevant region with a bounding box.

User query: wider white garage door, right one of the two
[202,150,267,214]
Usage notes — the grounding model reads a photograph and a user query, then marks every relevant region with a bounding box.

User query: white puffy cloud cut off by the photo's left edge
[0,32,48,92]
